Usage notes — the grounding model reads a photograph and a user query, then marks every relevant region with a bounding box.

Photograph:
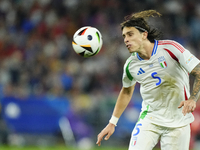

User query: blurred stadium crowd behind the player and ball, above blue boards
[0,0,200,149]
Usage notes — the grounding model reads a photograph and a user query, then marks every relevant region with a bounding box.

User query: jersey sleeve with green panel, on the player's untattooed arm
[122,59,136,87]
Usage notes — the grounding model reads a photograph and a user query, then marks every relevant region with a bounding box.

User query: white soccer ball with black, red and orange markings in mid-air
[72,26,103,57]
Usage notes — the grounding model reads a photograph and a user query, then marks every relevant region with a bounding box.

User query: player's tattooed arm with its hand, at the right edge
[179,64,200,115]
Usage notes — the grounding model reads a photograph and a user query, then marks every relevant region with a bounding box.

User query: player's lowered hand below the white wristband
[96,123,115,146]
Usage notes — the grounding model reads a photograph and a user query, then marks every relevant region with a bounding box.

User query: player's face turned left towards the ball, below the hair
[122,27,144,53]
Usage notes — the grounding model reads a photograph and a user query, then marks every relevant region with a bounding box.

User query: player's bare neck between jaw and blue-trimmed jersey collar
[138,41,154,60]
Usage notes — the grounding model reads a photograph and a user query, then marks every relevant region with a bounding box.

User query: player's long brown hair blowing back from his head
[120,10,161,43]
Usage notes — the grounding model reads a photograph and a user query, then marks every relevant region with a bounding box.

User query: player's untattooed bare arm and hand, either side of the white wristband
[96,84,135,146]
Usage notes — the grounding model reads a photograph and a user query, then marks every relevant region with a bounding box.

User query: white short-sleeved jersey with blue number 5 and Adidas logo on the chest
[122,40,200,127]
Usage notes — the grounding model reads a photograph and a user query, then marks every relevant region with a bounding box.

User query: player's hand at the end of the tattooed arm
[178,99,196,116]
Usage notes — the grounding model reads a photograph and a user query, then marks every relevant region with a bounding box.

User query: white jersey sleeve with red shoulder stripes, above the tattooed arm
[166,41,200,73]
